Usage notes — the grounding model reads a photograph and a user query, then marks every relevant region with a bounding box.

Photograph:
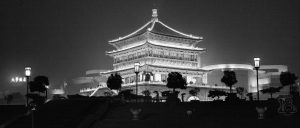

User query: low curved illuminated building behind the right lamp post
[202,64,288,99]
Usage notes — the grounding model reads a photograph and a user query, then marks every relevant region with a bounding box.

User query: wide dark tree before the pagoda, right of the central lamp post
[167,72,187,93]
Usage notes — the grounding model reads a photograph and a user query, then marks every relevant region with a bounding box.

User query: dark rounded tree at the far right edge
[280,72,298,94]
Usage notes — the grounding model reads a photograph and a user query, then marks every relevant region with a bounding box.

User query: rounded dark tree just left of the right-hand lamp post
[221,71,237,93]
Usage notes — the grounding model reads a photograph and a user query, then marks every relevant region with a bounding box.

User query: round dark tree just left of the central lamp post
[106,73,123,90]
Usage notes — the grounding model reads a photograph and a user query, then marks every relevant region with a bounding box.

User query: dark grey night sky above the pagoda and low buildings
[0,0,300,92]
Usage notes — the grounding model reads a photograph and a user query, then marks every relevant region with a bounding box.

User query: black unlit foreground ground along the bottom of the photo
[0,98,300,128]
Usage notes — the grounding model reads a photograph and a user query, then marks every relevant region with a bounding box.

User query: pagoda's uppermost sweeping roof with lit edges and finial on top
[108,9,203,44]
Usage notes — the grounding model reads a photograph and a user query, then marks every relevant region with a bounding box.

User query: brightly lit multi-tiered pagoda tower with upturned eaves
[81,9,230,100]
